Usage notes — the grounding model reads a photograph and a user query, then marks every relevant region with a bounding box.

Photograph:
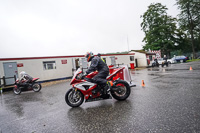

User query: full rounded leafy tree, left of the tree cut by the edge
[141,3,181,56]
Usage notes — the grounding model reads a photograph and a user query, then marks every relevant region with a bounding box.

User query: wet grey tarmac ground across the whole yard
[0,62,200,133]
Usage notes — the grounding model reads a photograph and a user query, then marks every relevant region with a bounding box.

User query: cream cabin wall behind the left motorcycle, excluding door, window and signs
[0,58,72,81]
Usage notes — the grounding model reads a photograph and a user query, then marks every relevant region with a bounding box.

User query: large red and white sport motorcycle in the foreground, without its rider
[65,67,135,107]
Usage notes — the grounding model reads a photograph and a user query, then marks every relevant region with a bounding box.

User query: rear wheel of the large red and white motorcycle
[111,80,131,101]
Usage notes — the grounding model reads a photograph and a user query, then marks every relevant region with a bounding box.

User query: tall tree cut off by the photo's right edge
[176,0,200,58]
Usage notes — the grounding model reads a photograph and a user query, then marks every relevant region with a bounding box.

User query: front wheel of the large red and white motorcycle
[65,88,84,107]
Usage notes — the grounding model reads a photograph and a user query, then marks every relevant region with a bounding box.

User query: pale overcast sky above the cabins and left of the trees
[0,0,179,58]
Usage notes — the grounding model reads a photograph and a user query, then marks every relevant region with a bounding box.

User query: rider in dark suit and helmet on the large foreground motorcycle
[84,52,113,95]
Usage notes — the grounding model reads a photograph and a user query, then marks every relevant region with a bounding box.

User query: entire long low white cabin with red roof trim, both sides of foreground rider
[0,53,135,85]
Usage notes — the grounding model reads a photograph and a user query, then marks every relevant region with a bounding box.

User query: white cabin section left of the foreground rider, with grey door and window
[0,55,83,85]
